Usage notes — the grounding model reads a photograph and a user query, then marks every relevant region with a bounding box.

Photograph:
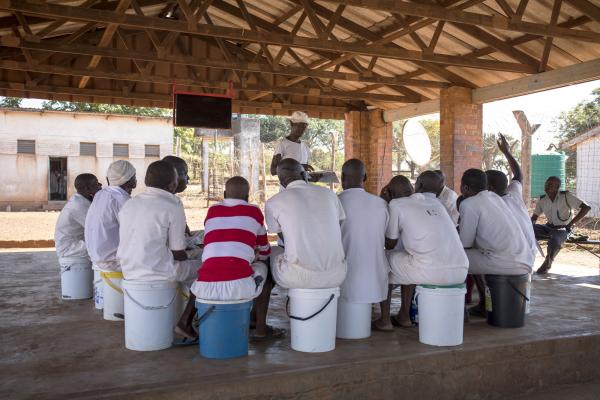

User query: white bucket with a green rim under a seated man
[417,285,467,346]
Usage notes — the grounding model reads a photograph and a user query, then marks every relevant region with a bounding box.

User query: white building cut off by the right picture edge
[563,126,600,218]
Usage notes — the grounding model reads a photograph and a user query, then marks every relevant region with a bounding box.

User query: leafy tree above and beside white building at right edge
[554,87,600,188]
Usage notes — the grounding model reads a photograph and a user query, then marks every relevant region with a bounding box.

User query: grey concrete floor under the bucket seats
[0,251,600,399]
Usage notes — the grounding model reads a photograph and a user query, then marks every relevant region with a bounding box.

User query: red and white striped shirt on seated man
[198,199,271,282]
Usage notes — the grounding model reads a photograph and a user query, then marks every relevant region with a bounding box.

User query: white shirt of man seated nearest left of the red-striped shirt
[117,187,188,281]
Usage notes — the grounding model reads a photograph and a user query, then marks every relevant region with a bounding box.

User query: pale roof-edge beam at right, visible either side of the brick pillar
[384,59,600,122]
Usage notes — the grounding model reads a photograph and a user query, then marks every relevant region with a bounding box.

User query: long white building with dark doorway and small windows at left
[0,109,173,211]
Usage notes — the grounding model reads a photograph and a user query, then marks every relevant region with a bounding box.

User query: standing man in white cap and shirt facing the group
[271,111,314,176]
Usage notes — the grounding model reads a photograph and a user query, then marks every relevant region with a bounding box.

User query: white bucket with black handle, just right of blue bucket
[288,288,340,353]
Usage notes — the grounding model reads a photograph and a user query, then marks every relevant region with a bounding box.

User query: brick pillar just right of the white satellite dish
[440,86,483,194]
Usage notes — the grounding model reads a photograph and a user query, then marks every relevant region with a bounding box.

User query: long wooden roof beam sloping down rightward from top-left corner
[0,0,536,73]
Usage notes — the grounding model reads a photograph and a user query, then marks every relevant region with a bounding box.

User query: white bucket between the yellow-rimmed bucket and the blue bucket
[122,280,178,351]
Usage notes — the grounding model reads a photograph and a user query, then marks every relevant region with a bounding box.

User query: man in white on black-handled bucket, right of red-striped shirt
[265,158,346,289]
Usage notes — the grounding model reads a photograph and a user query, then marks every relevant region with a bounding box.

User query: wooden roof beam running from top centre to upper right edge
[327,0,600,43]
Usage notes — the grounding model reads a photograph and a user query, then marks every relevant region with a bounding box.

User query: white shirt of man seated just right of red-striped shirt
[265,180,346,284]
